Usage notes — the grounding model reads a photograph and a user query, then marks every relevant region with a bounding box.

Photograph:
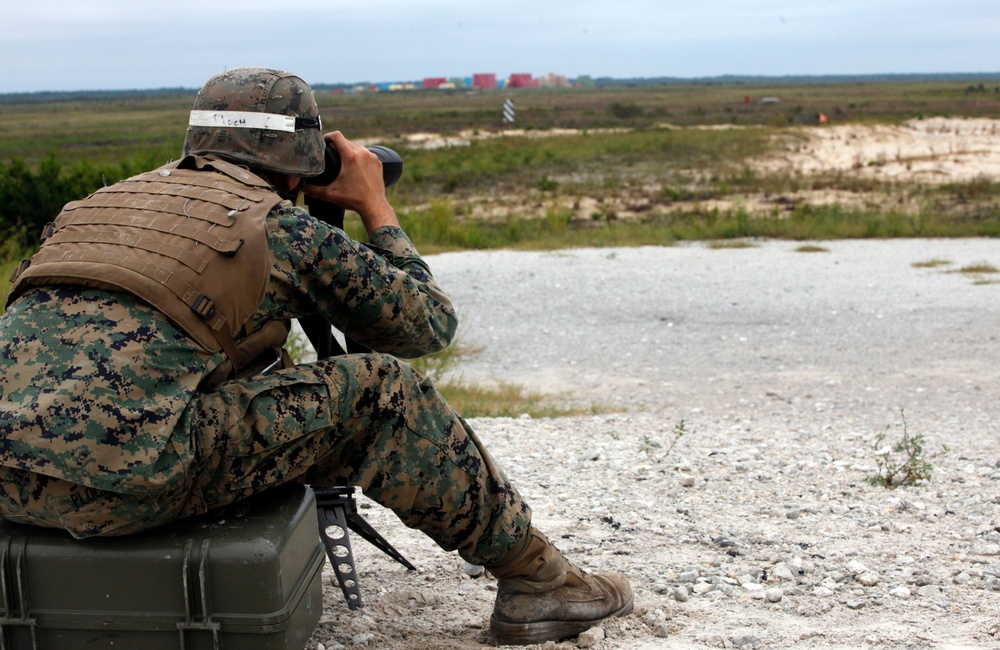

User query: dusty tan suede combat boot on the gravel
[486,528,632,645]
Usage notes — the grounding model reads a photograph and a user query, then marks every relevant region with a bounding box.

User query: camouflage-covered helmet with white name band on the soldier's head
[184,68,325,176]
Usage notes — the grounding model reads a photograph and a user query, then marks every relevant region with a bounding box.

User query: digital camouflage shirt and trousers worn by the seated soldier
[0,201,530,565]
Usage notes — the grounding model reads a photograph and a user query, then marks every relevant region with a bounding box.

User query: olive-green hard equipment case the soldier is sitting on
[0,485,326,650]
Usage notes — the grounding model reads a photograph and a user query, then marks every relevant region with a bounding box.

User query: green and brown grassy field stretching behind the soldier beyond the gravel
[0,82,1000,242]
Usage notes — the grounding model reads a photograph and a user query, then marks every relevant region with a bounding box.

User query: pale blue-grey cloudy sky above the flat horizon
[0,0,1000,93]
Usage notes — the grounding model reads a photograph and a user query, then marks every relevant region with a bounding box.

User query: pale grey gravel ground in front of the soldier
[311,240,1000,650]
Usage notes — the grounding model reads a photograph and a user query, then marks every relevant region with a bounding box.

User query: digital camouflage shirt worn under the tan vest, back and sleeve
[0,202,457,494]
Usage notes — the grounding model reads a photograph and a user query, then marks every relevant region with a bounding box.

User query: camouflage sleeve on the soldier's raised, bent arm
[258,203,458,358]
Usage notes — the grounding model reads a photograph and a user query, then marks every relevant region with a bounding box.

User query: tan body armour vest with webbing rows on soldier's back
[7,156,288,387]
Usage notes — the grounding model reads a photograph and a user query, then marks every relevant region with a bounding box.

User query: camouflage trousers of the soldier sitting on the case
[3,354,531,564]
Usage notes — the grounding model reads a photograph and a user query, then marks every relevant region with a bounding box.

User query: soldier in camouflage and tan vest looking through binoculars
[0,68,632,644]
